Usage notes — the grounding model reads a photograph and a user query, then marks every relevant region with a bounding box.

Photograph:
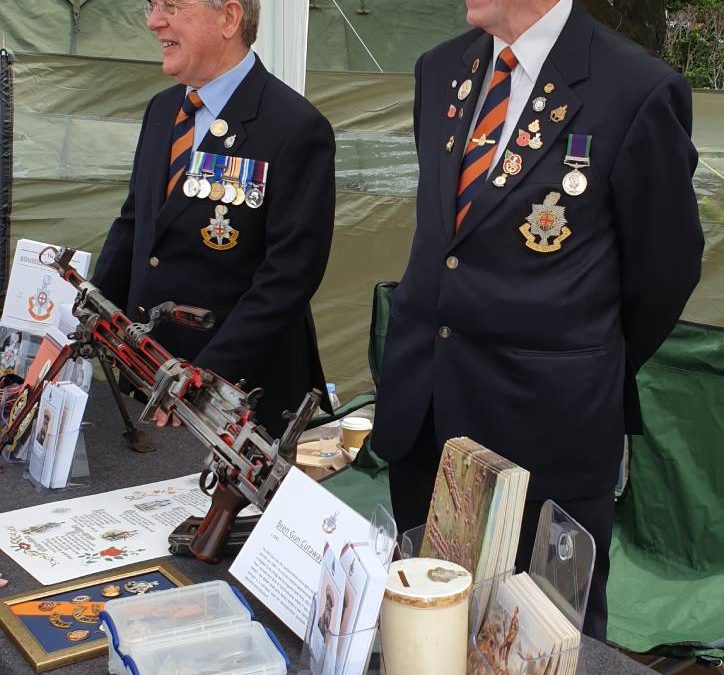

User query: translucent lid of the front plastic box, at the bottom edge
[123,621,288,675]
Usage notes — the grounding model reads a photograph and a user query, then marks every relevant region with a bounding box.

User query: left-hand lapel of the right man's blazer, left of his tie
[439,33,493,238]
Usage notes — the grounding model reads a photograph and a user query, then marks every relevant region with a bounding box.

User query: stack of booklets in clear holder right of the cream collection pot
[467,573,581,675]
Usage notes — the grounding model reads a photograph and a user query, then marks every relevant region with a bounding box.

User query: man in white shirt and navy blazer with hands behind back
[373,0,703,638]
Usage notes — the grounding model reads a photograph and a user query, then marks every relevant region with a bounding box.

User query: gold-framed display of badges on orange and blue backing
[0,562,193,673]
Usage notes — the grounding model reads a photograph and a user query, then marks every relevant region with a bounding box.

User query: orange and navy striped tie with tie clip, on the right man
[455,47,518,231]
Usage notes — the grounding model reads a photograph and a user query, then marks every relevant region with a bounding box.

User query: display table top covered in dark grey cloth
[0,380,654,675]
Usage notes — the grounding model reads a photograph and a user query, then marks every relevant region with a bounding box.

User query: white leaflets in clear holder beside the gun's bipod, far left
[28,382,88,488]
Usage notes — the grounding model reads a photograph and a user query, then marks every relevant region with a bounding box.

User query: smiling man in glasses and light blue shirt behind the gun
[93,0,335,433]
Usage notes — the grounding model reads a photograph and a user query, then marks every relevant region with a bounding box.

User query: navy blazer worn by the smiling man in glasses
[93,57,335,433]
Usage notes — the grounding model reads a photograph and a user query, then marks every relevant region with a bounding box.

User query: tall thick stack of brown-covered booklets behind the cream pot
[420,438,530,587]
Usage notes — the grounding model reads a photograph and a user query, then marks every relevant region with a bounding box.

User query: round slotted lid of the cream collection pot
[385,558,473,609]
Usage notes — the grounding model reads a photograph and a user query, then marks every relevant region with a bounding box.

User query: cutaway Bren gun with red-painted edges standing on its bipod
[0,247,321,563]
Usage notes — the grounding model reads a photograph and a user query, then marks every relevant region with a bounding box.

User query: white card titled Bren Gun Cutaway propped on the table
[229,468,370,639]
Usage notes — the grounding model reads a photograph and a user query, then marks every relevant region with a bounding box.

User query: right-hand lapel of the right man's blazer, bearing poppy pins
[451,3,593,247]
